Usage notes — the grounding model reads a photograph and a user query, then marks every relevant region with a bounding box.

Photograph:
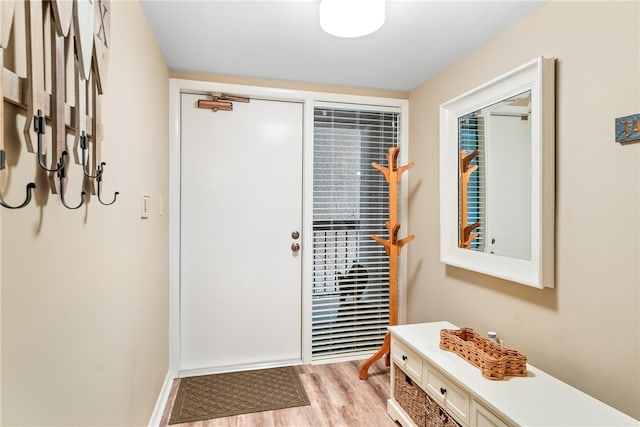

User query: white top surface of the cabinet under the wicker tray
[389,322,640,427]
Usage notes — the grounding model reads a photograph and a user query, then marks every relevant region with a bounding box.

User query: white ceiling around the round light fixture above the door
[141,0,545,91]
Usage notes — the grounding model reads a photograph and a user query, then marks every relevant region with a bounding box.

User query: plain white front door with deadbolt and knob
[179,94,303,373]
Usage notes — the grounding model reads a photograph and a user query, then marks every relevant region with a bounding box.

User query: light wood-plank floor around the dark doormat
[160,361,397,427]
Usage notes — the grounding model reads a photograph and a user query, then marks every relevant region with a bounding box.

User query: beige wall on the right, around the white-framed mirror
[408,1,640,418]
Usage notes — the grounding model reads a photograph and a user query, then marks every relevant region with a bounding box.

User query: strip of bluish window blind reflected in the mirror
[458,113,486,251]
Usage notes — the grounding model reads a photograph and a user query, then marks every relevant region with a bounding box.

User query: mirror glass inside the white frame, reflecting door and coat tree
[458,90,532,260]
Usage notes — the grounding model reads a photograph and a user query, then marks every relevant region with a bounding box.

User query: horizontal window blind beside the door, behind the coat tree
[312,108,399,359]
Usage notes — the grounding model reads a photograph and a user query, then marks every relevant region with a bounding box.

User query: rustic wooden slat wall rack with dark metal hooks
[0,0,119,209]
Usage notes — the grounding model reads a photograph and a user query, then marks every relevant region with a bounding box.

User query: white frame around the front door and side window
[169,79,410,378]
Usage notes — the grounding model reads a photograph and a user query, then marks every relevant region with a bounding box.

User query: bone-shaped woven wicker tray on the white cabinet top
[440,328,527,380]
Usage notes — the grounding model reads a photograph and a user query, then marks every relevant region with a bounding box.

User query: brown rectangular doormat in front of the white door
[169,366,309,424]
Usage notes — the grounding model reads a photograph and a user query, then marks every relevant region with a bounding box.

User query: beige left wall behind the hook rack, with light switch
[0,1,169,426]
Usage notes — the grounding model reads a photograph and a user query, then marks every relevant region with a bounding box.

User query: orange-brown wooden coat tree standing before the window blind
[360,147,414,380]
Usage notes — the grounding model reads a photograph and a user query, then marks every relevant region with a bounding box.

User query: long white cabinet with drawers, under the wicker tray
[387,322,640,427]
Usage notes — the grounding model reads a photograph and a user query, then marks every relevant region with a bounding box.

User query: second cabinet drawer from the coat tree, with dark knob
[424,364,470,425]
